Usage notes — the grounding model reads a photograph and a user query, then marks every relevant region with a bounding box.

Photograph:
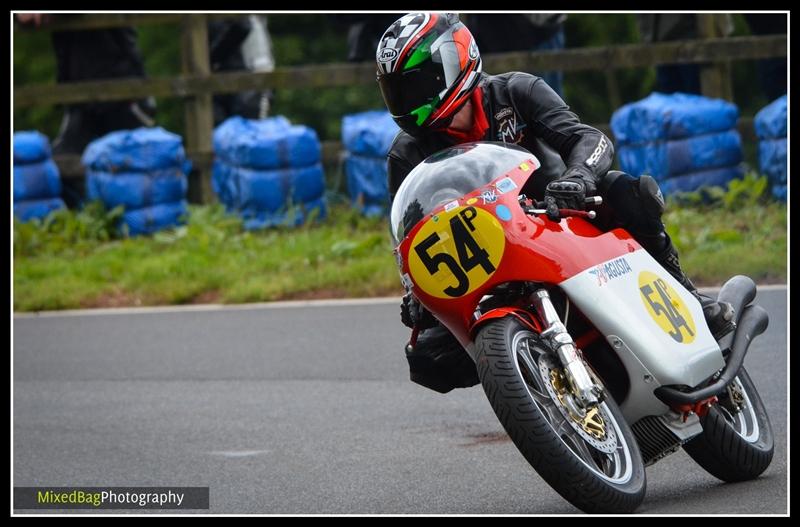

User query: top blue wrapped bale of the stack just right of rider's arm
[611,92,739,145]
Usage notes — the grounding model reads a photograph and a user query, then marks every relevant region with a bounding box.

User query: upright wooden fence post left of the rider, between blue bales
[181,14,214,203]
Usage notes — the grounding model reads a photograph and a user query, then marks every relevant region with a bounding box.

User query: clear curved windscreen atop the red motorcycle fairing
[390,141,533,245]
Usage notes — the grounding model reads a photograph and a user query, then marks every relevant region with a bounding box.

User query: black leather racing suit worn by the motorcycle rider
[388,72,668,393]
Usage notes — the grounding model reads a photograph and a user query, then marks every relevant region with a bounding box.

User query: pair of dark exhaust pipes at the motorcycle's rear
[653,276,769,406]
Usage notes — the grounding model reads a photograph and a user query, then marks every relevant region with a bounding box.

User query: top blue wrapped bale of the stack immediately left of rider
[342,110,400,157]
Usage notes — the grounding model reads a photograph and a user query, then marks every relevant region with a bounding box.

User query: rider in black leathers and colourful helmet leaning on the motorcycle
[376,13,733,393]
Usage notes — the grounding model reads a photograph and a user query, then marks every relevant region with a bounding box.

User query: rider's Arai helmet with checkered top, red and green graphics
[375,13,481,135]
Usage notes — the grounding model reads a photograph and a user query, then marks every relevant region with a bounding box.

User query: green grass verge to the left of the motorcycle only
[14,201,402,311]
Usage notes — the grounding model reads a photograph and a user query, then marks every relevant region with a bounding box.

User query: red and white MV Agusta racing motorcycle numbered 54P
[390,142,773,513]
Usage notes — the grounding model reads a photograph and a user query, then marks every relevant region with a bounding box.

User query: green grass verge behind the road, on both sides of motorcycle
[14,177,787,311]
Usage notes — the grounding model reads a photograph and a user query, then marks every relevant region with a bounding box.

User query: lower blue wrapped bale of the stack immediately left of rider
[344,154,389,216]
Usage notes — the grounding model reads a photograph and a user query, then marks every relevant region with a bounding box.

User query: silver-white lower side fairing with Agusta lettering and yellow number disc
[559,249,725,393]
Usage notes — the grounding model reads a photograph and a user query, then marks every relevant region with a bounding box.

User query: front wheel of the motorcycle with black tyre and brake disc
[475,317,646,513]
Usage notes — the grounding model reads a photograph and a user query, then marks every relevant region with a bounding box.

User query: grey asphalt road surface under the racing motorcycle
[13,289,788,514]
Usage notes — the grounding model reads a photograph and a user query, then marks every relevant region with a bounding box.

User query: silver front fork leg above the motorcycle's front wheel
[531,289,603,408]
